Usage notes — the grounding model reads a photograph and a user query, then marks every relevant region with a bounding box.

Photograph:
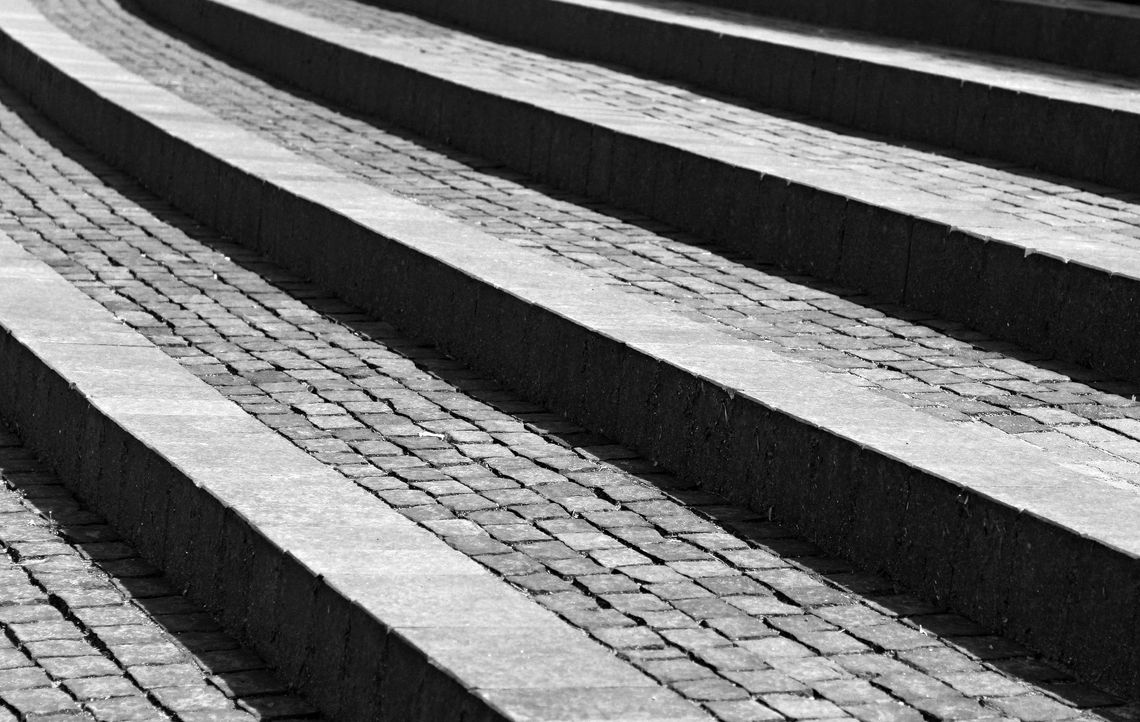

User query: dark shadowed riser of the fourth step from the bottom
[337,0,1140,190]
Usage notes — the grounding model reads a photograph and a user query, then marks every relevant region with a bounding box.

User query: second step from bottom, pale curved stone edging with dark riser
[0,3,1140,695]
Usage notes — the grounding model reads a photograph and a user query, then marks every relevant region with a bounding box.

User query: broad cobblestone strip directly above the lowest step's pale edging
[0,80,1140,722]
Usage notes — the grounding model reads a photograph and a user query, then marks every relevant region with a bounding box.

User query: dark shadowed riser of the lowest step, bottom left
[0,328,506,722]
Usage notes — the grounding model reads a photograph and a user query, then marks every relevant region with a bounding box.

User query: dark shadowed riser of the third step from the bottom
[143,0,1140,387]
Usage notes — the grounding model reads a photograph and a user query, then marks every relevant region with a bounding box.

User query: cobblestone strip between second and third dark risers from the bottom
[24,0,1140,489]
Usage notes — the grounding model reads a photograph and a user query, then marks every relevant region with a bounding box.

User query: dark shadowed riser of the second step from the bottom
[0,8,1140,692]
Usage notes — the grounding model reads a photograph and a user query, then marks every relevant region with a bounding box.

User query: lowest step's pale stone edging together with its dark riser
[0,233,709,722]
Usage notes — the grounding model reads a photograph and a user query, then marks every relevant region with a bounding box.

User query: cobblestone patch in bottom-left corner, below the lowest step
[0,421,318,722]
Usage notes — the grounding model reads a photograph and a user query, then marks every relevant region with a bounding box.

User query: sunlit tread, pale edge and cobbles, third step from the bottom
[226,0,1140,278]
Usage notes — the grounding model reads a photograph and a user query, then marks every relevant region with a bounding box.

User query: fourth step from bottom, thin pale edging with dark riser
[264,0,1140,190]
